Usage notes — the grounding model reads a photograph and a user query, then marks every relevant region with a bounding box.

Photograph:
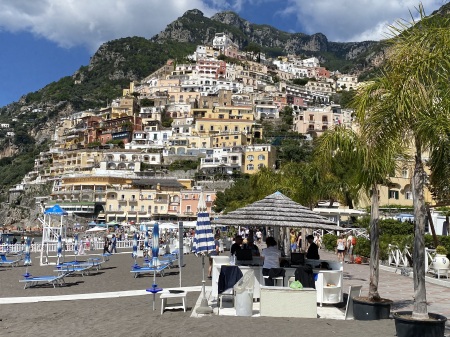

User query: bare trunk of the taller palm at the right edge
[412,143,428,319]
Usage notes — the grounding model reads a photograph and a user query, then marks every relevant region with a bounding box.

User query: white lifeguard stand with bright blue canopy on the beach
[41,205,67,266]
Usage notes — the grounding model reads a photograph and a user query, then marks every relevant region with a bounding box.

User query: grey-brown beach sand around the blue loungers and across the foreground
[0,252,395,337]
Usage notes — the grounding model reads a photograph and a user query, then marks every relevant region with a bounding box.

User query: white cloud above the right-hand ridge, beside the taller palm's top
[280,0,443,41]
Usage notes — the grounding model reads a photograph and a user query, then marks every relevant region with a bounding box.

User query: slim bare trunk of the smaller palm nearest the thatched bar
[369,184,380,301]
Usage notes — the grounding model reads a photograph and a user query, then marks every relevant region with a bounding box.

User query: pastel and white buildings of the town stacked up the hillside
[5,33,422,223]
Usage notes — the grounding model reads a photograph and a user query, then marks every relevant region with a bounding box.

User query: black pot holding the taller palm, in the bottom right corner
[393,311,447,337]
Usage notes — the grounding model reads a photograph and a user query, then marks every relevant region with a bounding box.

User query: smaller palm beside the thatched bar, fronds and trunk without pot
[318,124,402,301]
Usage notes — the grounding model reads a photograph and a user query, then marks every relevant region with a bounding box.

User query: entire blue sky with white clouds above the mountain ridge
[0,0,445,107]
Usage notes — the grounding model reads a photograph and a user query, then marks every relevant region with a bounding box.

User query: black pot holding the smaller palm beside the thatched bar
[353,297,392,321]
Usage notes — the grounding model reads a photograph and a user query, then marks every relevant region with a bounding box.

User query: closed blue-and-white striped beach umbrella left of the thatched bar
[194,193,216,254]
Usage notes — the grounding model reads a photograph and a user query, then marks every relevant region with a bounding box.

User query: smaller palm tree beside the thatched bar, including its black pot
[318,122,403,320]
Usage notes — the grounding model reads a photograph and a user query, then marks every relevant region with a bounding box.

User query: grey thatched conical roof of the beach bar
[212,192,339,230]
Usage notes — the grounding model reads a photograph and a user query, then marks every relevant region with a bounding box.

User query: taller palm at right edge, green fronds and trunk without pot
[356,4,450,319]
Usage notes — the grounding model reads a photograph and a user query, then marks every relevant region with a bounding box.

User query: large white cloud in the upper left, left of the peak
[0,0,217,51]
